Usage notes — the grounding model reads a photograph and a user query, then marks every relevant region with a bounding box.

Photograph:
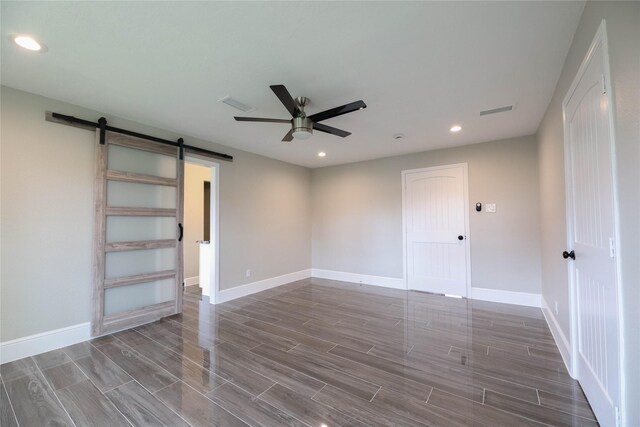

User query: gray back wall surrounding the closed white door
[311,136,540,293]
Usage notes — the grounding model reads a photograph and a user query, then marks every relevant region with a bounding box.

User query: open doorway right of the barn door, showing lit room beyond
[183,156,219,304]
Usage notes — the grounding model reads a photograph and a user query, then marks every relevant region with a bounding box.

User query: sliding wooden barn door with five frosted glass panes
[92,130,184,336]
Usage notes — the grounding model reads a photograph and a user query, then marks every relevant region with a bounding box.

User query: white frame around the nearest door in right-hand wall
[562,19,626,422]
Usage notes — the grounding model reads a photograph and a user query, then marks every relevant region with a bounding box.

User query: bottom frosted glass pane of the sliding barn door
[104,279,176,316]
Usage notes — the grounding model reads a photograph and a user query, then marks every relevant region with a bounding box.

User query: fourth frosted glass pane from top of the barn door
[105,248,176,283]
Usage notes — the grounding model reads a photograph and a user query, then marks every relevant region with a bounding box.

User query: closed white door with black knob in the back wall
[403,164,469,296]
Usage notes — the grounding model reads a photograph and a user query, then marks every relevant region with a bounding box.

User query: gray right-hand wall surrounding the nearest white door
[538,2,640,426]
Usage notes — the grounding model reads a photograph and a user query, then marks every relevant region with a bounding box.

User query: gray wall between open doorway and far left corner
[220,144,311,290]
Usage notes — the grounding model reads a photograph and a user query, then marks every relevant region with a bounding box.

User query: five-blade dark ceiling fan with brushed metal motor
[234,85,367,142]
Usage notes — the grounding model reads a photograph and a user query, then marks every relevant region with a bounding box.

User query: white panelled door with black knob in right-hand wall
[563,20,620,426]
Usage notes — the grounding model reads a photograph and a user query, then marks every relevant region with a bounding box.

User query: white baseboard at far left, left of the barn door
[0,322,91,363]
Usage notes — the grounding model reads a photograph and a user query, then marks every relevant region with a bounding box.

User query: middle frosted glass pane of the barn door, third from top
[107,216,178,243]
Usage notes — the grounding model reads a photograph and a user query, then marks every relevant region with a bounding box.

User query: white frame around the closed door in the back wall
[400,162,471,298]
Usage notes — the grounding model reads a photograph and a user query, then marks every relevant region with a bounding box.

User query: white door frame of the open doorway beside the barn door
[184,154,220,304]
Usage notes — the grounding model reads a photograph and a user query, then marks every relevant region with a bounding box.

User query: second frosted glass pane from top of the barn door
[107,181,176,209]
